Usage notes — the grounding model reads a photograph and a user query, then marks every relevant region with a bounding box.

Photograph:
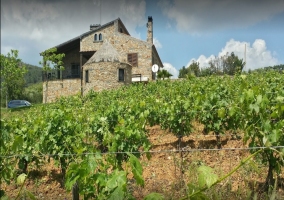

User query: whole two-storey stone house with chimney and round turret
[43,17,163,103]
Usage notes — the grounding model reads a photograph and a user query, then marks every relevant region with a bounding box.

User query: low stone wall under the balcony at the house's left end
[43,79,81,103]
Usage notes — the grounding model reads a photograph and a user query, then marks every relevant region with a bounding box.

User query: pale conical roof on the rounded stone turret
[86,40,119,64]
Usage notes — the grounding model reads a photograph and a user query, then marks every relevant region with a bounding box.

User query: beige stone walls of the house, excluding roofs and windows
[43,20,162,102]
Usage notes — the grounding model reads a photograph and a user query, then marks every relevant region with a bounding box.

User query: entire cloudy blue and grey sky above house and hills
[1,0,284,76]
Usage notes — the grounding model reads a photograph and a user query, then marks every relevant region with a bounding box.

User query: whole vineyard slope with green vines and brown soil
[0,71,284,200]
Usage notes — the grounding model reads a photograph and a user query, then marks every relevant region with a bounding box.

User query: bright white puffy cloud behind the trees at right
[187,39,278,70]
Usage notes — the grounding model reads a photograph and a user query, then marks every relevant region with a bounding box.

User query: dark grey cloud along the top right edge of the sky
[158,0,284,34]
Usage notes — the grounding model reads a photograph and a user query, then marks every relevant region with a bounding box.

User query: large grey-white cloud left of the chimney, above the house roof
[1,0,147,64]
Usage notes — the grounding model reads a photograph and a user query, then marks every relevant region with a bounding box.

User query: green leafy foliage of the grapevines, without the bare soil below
[0,71,284,199]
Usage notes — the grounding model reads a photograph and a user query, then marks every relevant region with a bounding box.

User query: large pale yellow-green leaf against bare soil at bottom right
[197,165,218,188]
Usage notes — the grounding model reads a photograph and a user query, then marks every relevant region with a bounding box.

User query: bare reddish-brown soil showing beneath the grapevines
[1,125,284,200]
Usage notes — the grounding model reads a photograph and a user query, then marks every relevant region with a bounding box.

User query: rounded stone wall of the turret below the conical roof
[83,62,131,95]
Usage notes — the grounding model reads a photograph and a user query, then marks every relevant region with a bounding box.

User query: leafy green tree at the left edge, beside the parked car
[1,49,27,107]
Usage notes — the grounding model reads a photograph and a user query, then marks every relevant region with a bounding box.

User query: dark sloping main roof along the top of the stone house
[50,18,130,53]
